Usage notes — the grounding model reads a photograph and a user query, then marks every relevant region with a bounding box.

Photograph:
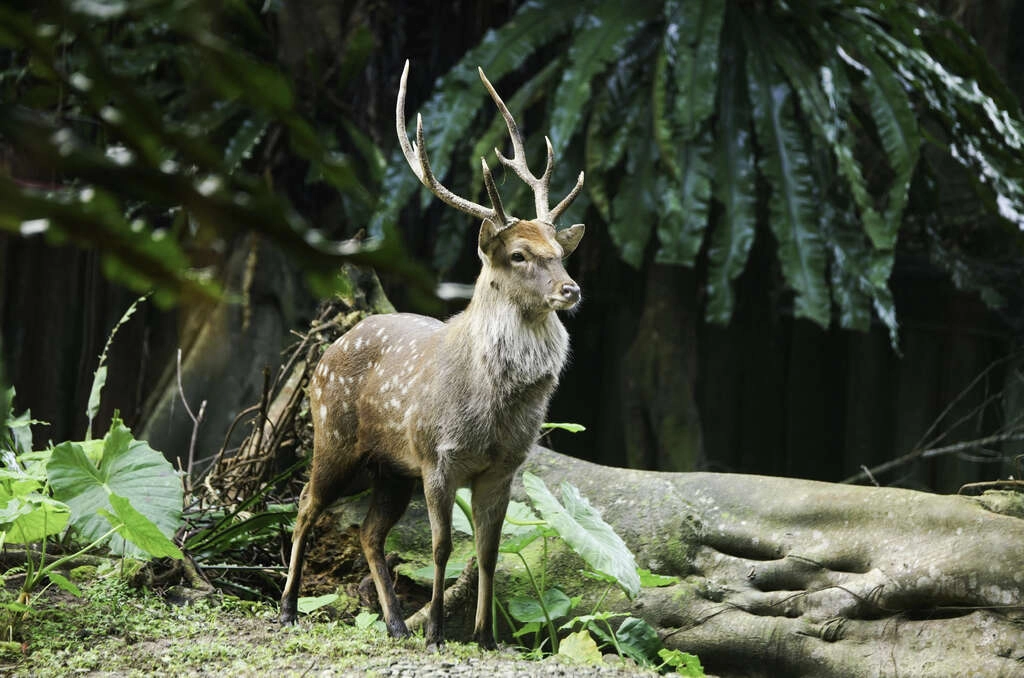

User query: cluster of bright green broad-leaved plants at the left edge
[0,305,182,626]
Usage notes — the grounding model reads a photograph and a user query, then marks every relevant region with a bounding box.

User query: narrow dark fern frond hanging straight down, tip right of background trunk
[705,10,757,325]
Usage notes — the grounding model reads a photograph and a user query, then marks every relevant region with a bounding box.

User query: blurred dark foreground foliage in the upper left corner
[0,0,432,303]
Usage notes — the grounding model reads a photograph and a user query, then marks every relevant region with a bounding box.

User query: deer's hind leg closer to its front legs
[359,471,415,638]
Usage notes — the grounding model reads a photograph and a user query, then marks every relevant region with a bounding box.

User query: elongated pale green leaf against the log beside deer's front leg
[522,471,640,597]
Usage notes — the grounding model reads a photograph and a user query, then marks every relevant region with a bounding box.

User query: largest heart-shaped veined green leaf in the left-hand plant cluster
[46,418,181,554]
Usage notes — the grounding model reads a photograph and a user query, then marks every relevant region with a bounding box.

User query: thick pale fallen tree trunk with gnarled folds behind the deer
[321,448,1024,678]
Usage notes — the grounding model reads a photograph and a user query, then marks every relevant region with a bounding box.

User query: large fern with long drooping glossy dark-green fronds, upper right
[375,0,1024,345]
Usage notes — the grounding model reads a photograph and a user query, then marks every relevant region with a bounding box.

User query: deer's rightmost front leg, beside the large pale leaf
[473,477,512,649]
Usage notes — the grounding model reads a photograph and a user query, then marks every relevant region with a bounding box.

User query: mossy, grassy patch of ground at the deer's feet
[0,578,657,678]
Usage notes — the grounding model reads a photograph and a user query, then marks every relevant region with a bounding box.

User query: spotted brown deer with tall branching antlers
[280,60,584,650]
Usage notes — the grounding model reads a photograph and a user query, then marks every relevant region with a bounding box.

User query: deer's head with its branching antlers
[395,61,584,315]
